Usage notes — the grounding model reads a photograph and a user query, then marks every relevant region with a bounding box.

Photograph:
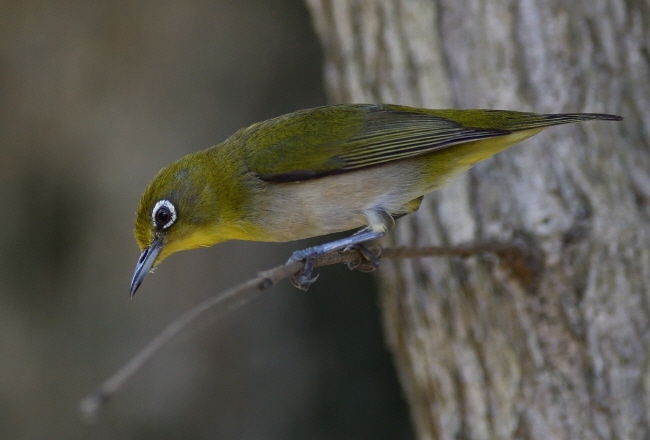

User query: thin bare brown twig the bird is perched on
[79,242,536,421]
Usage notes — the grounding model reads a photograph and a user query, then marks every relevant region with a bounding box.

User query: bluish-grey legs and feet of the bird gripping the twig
[287,209,395,290]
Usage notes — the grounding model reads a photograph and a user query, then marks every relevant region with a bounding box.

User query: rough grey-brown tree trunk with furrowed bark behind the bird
[307,0,650,440]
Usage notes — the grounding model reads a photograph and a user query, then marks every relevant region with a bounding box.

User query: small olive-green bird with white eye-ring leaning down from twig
[131,104,623,296]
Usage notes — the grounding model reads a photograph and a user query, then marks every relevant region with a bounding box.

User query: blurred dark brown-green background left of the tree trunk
[0,0,412,439]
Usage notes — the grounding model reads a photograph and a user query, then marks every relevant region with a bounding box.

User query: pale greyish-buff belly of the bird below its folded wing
[246,160,436,241]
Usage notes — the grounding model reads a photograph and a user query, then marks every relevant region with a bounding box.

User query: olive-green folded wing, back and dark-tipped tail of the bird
[239,105,616,182]
